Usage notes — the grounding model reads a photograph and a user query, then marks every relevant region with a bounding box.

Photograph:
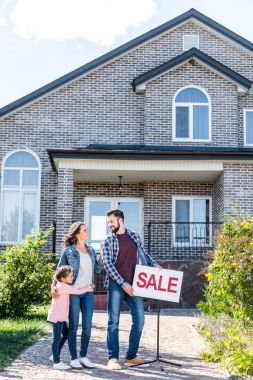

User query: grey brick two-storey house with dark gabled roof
[0,9,253,306]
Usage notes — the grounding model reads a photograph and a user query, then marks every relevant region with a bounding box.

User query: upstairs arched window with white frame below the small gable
[173,86,211,141]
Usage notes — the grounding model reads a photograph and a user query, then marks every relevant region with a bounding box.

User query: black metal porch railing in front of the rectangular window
[148,221,222,260]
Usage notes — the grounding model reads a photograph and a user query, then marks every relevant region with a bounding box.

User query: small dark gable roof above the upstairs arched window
[132,48,252,93]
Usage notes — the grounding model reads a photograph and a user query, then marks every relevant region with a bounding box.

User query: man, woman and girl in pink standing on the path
[48,209,161,370]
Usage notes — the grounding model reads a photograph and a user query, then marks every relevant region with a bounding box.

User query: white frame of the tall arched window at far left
[0,149,41,245]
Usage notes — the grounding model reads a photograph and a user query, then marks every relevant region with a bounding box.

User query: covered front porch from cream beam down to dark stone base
[48,146,226,308]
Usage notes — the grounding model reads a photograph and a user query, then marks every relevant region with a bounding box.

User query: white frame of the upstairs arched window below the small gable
[172,85,212,143]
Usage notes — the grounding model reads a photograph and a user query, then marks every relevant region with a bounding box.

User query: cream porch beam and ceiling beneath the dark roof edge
[57,158,223,183]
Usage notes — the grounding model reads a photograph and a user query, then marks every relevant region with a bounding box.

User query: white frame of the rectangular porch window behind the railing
[172,195,213,248]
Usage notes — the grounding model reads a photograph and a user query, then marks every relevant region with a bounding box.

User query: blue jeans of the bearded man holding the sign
[107,283,144,359]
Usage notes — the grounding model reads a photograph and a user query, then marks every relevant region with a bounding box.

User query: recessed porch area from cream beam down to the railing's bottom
[49,161,222,255]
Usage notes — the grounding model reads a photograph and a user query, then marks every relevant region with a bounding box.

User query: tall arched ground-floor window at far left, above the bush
[0,150,41,243]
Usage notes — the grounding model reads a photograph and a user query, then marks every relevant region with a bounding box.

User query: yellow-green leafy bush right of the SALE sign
[198,218,253,376]
